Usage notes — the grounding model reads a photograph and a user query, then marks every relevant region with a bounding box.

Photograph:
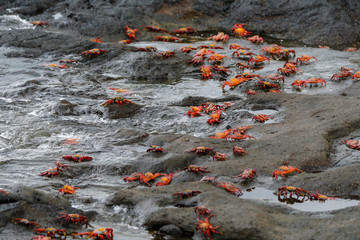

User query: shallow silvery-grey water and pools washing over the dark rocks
[0,15,357,239]
